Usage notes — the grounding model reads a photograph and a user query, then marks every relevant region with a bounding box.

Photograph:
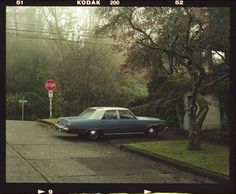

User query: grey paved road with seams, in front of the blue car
[6,121,216,183]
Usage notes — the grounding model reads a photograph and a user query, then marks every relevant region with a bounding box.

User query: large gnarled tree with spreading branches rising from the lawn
[95,7,229,150]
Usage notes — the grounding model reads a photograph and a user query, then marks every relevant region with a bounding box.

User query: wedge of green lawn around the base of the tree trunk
[126,140,229,176]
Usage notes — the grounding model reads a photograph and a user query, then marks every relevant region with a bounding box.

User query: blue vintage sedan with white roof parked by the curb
[55,107,167,140]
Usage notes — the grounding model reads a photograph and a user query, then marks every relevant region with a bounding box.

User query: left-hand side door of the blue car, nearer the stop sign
[102,110,119,135]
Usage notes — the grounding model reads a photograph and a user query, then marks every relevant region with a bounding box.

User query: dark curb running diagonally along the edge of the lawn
[120,145,229,183]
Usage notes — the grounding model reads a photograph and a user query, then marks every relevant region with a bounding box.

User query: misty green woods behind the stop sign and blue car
[6,7,146,119]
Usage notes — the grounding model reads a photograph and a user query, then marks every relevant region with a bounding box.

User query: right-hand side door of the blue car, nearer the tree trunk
[118,110,145,134]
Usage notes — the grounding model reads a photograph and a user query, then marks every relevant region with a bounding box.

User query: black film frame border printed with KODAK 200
[0,0,236,193]
